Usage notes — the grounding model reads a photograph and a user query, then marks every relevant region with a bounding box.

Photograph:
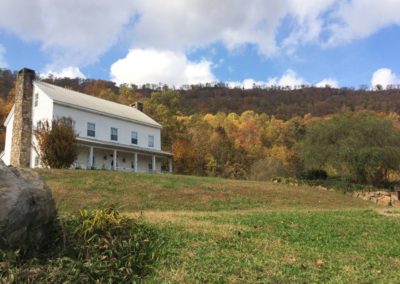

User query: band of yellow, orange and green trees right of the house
[144,91,400,185]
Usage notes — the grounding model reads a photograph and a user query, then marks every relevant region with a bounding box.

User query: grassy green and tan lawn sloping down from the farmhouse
[40,170,400,283]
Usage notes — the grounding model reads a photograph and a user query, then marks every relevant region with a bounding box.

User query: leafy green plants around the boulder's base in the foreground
[0,209,163,283]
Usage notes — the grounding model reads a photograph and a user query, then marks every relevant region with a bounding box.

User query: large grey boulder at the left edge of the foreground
[0,160,56,247]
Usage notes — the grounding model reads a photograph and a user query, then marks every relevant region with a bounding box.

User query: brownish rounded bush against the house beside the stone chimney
[34,117,78,169]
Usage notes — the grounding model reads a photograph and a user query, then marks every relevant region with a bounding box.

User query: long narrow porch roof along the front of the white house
[76,137,173,157]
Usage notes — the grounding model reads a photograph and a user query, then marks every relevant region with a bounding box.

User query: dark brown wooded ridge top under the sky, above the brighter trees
[0,69,400,120]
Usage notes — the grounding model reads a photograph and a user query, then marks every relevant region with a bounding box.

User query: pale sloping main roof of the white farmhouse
[34,81,162,128]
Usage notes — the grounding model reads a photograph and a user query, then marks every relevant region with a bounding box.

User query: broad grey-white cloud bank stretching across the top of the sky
[0,0,400,69]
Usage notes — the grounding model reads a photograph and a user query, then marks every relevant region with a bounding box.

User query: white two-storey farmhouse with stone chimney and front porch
[0,68,172,172]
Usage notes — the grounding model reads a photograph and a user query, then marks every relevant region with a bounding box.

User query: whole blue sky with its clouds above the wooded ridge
[0,0,400,87]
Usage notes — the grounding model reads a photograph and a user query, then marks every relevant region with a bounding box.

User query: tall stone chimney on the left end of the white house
[11,68,35,168]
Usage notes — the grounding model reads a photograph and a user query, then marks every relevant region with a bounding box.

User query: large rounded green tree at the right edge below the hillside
[303,112,400,185]
